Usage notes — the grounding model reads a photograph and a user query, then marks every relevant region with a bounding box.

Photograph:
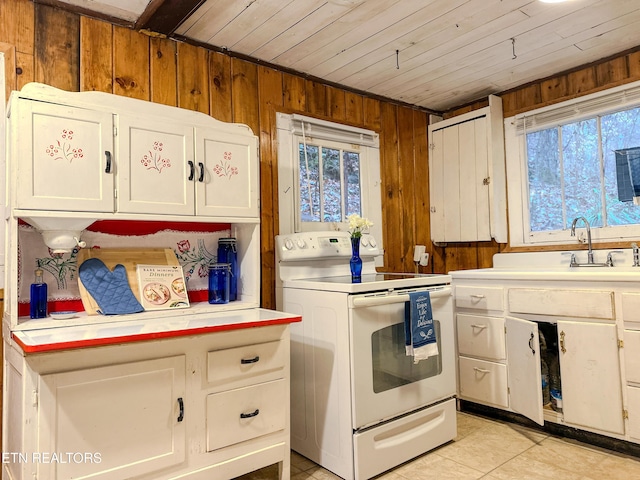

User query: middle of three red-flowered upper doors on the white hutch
[117,115,196,215]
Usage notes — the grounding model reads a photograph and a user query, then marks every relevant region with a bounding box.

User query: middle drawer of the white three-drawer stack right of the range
[456,313,506,360]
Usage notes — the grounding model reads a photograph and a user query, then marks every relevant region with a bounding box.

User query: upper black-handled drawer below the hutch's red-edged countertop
[207,340,287,388]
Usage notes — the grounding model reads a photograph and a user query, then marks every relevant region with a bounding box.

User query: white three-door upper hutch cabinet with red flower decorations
[9,84,259,221]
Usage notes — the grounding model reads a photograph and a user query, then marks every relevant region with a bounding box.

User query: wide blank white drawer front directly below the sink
[507,288,615,320]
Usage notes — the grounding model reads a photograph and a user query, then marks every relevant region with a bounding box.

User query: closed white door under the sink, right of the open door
[558,322,624,434]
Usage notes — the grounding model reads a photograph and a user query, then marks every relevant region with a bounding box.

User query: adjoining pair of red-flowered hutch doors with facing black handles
[117,115,259,217]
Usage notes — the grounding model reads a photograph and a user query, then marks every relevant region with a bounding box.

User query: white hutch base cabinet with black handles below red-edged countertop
[2,324,290,480]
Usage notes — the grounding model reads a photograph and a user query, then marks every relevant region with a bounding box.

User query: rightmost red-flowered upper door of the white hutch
[196,127,259,217]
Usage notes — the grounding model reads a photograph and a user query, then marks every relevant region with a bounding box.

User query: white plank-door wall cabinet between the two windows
[428,96,507,243]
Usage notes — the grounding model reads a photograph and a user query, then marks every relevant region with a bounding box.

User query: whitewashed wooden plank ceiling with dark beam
[35,0,640,111]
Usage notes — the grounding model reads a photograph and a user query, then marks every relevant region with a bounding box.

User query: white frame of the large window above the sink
[504,82,640,247]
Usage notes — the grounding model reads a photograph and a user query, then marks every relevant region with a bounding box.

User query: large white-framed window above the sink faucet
[505,83,640,246]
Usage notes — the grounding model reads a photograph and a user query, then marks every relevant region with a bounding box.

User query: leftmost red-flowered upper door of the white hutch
[11,99,115,213]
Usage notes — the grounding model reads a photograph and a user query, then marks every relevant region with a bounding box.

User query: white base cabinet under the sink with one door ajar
[452,280,624,439]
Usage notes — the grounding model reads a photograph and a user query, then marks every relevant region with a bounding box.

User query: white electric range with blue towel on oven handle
[276,232,456,480]
